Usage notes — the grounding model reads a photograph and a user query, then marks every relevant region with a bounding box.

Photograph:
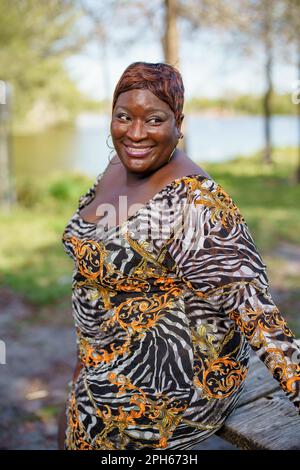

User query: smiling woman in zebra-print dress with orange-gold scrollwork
[60,62,300,450]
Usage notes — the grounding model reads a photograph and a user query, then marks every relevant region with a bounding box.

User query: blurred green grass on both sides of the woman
[0,149,300,306]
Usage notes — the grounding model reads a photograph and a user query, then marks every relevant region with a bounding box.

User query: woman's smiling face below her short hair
[110,89,183,174]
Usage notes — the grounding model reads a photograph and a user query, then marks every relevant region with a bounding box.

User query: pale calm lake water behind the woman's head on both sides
[12,114,297,178]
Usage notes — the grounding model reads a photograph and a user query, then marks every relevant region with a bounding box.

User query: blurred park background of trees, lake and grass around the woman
[0,0,300,449]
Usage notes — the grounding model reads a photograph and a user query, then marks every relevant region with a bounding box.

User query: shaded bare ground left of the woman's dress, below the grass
[0,289,76,449]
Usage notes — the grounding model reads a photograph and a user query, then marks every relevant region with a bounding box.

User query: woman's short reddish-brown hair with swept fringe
[112,62,184,129]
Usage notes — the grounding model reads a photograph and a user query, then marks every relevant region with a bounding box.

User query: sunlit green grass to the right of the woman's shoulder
[202,148,300,252]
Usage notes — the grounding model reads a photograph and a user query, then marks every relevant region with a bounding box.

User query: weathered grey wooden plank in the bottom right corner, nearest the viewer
[216,389,300,450]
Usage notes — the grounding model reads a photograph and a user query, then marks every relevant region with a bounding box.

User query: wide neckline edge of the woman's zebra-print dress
[77,173,213,232]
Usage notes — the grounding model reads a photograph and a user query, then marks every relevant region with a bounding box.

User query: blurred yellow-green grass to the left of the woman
[0,174,92,305]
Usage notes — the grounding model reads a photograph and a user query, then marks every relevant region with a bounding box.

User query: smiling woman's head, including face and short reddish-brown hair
[111,60,184,175]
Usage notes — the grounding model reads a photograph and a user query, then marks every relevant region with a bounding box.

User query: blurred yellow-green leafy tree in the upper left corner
[0,0,87,208]
